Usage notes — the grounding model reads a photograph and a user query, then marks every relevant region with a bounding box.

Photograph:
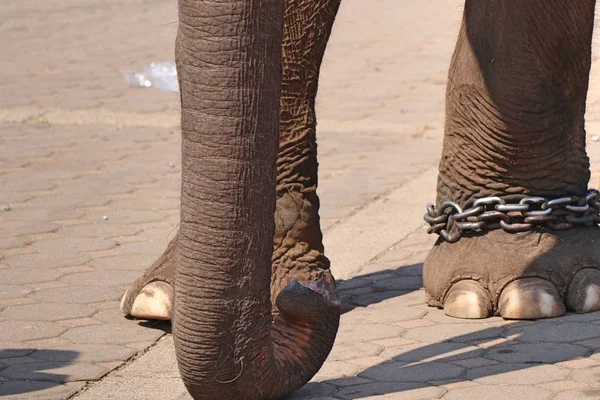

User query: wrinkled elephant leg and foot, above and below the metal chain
[423,0,600,319]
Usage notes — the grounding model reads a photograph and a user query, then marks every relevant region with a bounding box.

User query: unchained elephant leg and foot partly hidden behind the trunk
[121,0,340,319]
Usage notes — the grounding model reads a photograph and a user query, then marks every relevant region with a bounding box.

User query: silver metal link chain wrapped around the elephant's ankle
[424,189,600,243]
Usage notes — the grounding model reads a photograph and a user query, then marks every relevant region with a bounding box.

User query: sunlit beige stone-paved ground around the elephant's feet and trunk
[0,0,600,400]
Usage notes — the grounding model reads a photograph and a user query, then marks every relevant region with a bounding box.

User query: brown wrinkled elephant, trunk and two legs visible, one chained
[121,0,600,399]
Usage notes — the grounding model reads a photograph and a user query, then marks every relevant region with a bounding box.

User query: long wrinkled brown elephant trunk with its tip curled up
[173,0,340,399]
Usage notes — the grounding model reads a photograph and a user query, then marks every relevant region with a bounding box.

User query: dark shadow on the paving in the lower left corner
[0,348,79,399]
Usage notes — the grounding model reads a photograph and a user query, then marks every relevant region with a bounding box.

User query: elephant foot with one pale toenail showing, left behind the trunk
[121,237,178,321]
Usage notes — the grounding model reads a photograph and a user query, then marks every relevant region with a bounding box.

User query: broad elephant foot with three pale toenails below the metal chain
[423,225,600,319]
